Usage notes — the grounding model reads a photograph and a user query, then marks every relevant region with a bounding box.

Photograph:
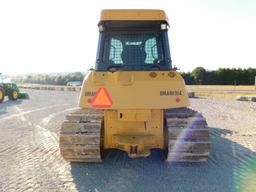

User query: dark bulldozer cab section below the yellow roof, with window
[96,20,171,71]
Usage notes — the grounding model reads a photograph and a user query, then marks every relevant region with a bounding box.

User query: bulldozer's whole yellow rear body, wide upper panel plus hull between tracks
[79,71,189,157]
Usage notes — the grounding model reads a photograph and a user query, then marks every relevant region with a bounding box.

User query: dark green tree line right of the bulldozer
[181,67,256,85]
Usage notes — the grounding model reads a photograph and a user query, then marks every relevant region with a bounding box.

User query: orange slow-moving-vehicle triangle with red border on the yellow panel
[91,87,113,108]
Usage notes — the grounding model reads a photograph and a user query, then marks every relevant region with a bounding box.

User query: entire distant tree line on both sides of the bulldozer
[12,67,256,85]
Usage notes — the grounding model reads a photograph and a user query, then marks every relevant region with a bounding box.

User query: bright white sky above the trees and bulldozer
[0,0,256,74]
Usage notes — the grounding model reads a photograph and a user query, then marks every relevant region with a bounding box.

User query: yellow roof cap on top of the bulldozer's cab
[100,9,168,21]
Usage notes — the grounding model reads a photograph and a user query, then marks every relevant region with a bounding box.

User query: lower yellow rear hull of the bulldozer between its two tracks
[104,109,164,157]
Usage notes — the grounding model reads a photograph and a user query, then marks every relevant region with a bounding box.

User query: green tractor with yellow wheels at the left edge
[0,73,29,103]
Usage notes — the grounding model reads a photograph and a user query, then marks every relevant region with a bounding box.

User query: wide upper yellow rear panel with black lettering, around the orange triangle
[79,71,189,110]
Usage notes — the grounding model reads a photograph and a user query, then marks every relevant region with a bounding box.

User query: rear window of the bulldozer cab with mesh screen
[103,34,163,65]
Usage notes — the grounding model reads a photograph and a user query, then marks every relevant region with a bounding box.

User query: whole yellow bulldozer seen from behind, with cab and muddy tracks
[60,10,210,162]
